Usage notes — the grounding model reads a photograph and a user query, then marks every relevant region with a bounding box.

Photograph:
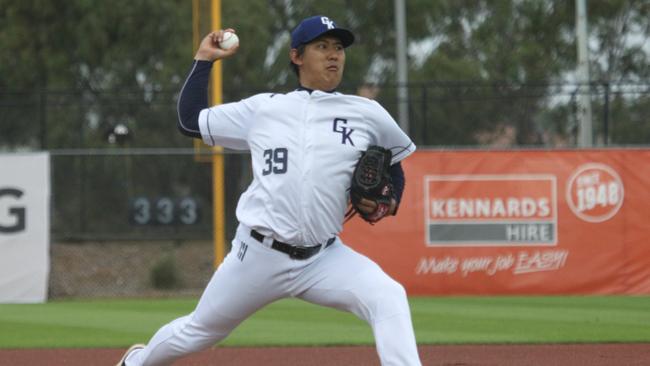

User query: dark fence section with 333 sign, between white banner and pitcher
[50,149,251,298]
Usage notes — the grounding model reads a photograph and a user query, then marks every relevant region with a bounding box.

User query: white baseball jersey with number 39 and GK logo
[199,90,415,246]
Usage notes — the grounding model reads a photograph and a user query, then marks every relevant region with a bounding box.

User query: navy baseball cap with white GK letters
[291,15,354,48]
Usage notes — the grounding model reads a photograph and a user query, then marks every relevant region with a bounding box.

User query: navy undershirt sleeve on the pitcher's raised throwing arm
[177,60,212,138]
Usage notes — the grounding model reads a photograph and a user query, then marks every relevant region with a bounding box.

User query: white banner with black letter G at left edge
[0,153,50,303]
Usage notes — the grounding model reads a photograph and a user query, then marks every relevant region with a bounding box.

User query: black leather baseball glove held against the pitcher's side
[346,145,393,224]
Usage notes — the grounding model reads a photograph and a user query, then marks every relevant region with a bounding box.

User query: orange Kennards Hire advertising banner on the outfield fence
[342,149,650,295]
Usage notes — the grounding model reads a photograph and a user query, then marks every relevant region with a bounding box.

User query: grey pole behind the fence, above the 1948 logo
[576,0,593,147]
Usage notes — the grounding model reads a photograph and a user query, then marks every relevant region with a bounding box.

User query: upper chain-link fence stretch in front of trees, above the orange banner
[5,81,650,150]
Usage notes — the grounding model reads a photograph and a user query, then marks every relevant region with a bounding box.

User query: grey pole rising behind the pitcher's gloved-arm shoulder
[395,0,409,133]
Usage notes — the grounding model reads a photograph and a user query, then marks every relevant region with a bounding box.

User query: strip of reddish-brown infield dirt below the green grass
[0,343,650,366]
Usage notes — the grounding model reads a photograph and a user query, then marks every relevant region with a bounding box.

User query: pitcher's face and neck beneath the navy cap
[294,36,345,91]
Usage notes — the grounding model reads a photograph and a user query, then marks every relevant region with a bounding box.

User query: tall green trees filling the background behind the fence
[0,0,650,148]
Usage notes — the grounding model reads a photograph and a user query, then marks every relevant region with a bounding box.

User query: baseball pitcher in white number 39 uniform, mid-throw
[118,15,421,366]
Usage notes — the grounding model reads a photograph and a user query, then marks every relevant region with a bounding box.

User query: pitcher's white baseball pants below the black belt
[126,225,421,366]
